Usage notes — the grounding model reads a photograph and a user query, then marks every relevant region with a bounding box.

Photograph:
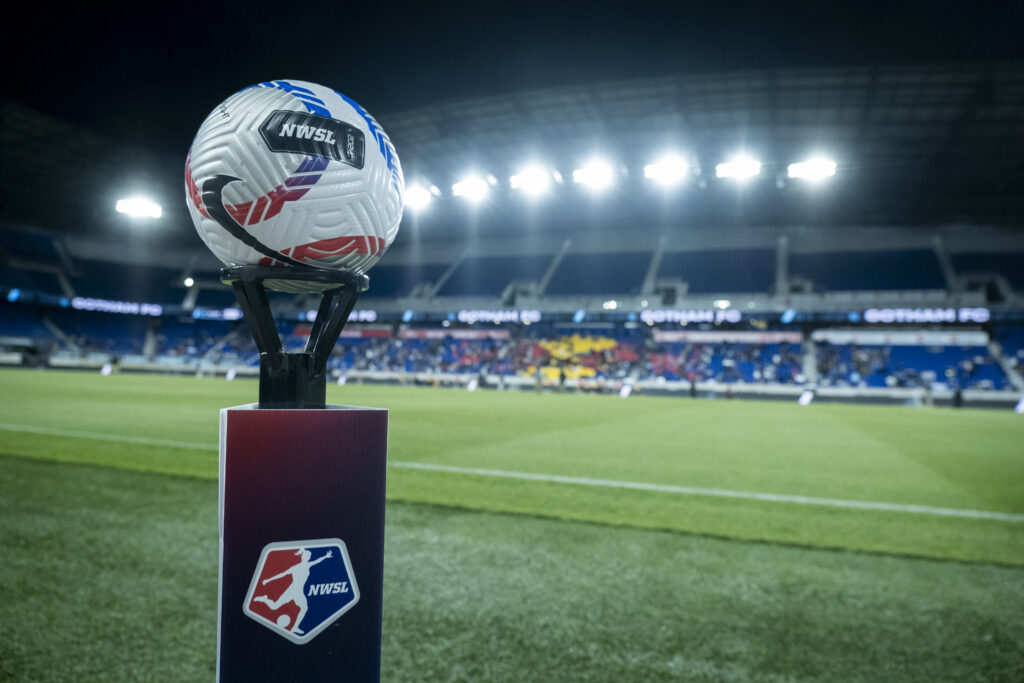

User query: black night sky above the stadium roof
[8,1,1024,155]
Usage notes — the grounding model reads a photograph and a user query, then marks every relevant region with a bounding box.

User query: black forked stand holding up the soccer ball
[220,265,370,410]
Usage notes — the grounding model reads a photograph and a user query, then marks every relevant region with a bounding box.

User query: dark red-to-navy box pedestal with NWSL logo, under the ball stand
[217,405,387,681]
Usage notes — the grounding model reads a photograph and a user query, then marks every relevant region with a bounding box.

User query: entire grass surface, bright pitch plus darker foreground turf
[0,371,1024,681]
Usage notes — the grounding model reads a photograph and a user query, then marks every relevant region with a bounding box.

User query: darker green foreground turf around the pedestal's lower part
[0,456,1024,682]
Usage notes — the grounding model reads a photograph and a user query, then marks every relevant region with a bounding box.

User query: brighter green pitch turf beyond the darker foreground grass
[0,371,1024,564]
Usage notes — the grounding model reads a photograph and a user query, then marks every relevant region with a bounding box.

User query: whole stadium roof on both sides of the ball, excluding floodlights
[0,62,1024,258]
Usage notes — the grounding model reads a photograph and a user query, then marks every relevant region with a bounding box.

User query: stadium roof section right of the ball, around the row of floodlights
[382,63,1024,224]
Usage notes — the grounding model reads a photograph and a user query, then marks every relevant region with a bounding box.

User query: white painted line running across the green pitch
[0,422,1024,523]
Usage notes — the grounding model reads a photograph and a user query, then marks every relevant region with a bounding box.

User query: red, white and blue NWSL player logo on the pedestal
[242,539,359,644]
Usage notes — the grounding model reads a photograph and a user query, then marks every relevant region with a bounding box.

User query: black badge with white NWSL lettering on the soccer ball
[259,111,366,168]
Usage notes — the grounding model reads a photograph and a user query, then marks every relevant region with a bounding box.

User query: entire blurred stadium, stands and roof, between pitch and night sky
[0,66,1024,401]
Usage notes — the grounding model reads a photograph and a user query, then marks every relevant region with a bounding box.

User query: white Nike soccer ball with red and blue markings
[185,81,406,292]
